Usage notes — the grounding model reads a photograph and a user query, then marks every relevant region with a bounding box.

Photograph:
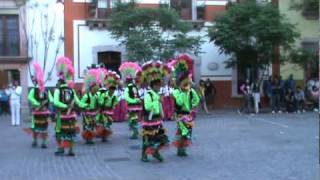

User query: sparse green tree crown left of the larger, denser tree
[110,1,202,62]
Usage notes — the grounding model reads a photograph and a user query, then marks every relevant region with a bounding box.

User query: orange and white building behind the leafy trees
[64,0,245,108]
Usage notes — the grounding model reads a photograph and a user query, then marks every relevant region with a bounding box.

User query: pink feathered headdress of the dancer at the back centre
[119,62,141,79]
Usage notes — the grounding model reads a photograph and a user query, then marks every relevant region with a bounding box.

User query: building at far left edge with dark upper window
[0,0,29,114]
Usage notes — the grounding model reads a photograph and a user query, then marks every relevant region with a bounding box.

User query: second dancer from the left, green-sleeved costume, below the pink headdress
[54,83,87,156]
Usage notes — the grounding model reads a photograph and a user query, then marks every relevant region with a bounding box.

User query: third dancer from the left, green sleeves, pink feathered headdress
[81,68,100,144]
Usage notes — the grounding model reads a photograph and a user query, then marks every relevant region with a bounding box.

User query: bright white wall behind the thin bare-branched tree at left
[25,0,64,87]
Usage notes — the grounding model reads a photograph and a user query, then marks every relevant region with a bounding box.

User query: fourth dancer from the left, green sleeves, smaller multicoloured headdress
[96,71,120,142]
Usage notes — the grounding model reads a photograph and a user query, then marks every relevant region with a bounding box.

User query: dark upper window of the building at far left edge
[0,15,20,56]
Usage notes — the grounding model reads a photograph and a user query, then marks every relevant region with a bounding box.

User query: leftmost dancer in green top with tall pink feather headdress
[28,63,53,148]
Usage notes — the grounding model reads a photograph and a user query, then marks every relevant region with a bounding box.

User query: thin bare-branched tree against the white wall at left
[16,0,64,82]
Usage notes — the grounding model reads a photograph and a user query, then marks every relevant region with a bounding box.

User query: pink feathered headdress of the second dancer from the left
[56,57,74,87]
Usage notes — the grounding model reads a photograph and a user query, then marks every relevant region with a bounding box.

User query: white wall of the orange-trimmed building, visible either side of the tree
[73,20,232,82]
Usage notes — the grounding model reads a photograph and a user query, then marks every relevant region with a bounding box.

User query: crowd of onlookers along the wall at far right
[238,75,319,113]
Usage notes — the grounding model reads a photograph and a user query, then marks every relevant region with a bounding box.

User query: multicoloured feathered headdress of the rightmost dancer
[170,54,193,85]
